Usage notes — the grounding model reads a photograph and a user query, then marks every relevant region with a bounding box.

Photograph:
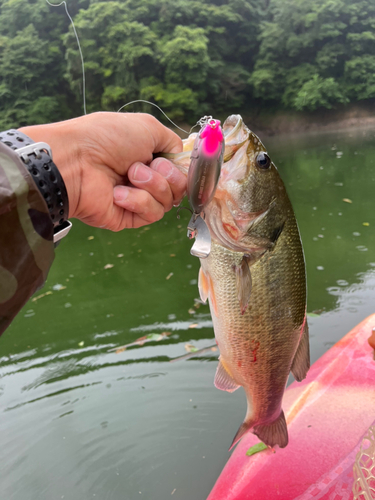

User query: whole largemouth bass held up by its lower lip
[171,115,310,448]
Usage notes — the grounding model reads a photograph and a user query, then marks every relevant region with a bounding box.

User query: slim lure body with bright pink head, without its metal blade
[187,119,224,214]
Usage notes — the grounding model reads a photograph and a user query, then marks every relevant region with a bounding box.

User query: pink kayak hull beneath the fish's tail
[208,314,375,500]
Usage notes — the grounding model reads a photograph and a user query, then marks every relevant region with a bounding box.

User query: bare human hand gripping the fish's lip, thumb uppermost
[20,112,186,231]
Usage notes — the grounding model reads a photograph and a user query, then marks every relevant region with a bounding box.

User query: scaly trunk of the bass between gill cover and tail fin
[201,223,306,425]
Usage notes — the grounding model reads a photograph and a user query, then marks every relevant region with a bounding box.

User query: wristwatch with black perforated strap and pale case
[0,129,72,243]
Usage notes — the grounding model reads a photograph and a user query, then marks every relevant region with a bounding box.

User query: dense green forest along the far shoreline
[0,0,375,130]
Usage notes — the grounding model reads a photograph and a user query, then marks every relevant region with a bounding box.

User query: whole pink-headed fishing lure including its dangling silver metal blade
[187,116,225,259]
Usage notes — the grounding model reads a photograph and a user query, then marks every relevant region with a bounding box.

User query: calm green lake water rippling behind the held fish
[0,126,375,500]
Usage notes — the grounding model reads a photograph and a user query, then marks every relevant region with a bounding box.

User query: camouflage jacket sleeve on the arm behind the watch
[0,143,54,335]
